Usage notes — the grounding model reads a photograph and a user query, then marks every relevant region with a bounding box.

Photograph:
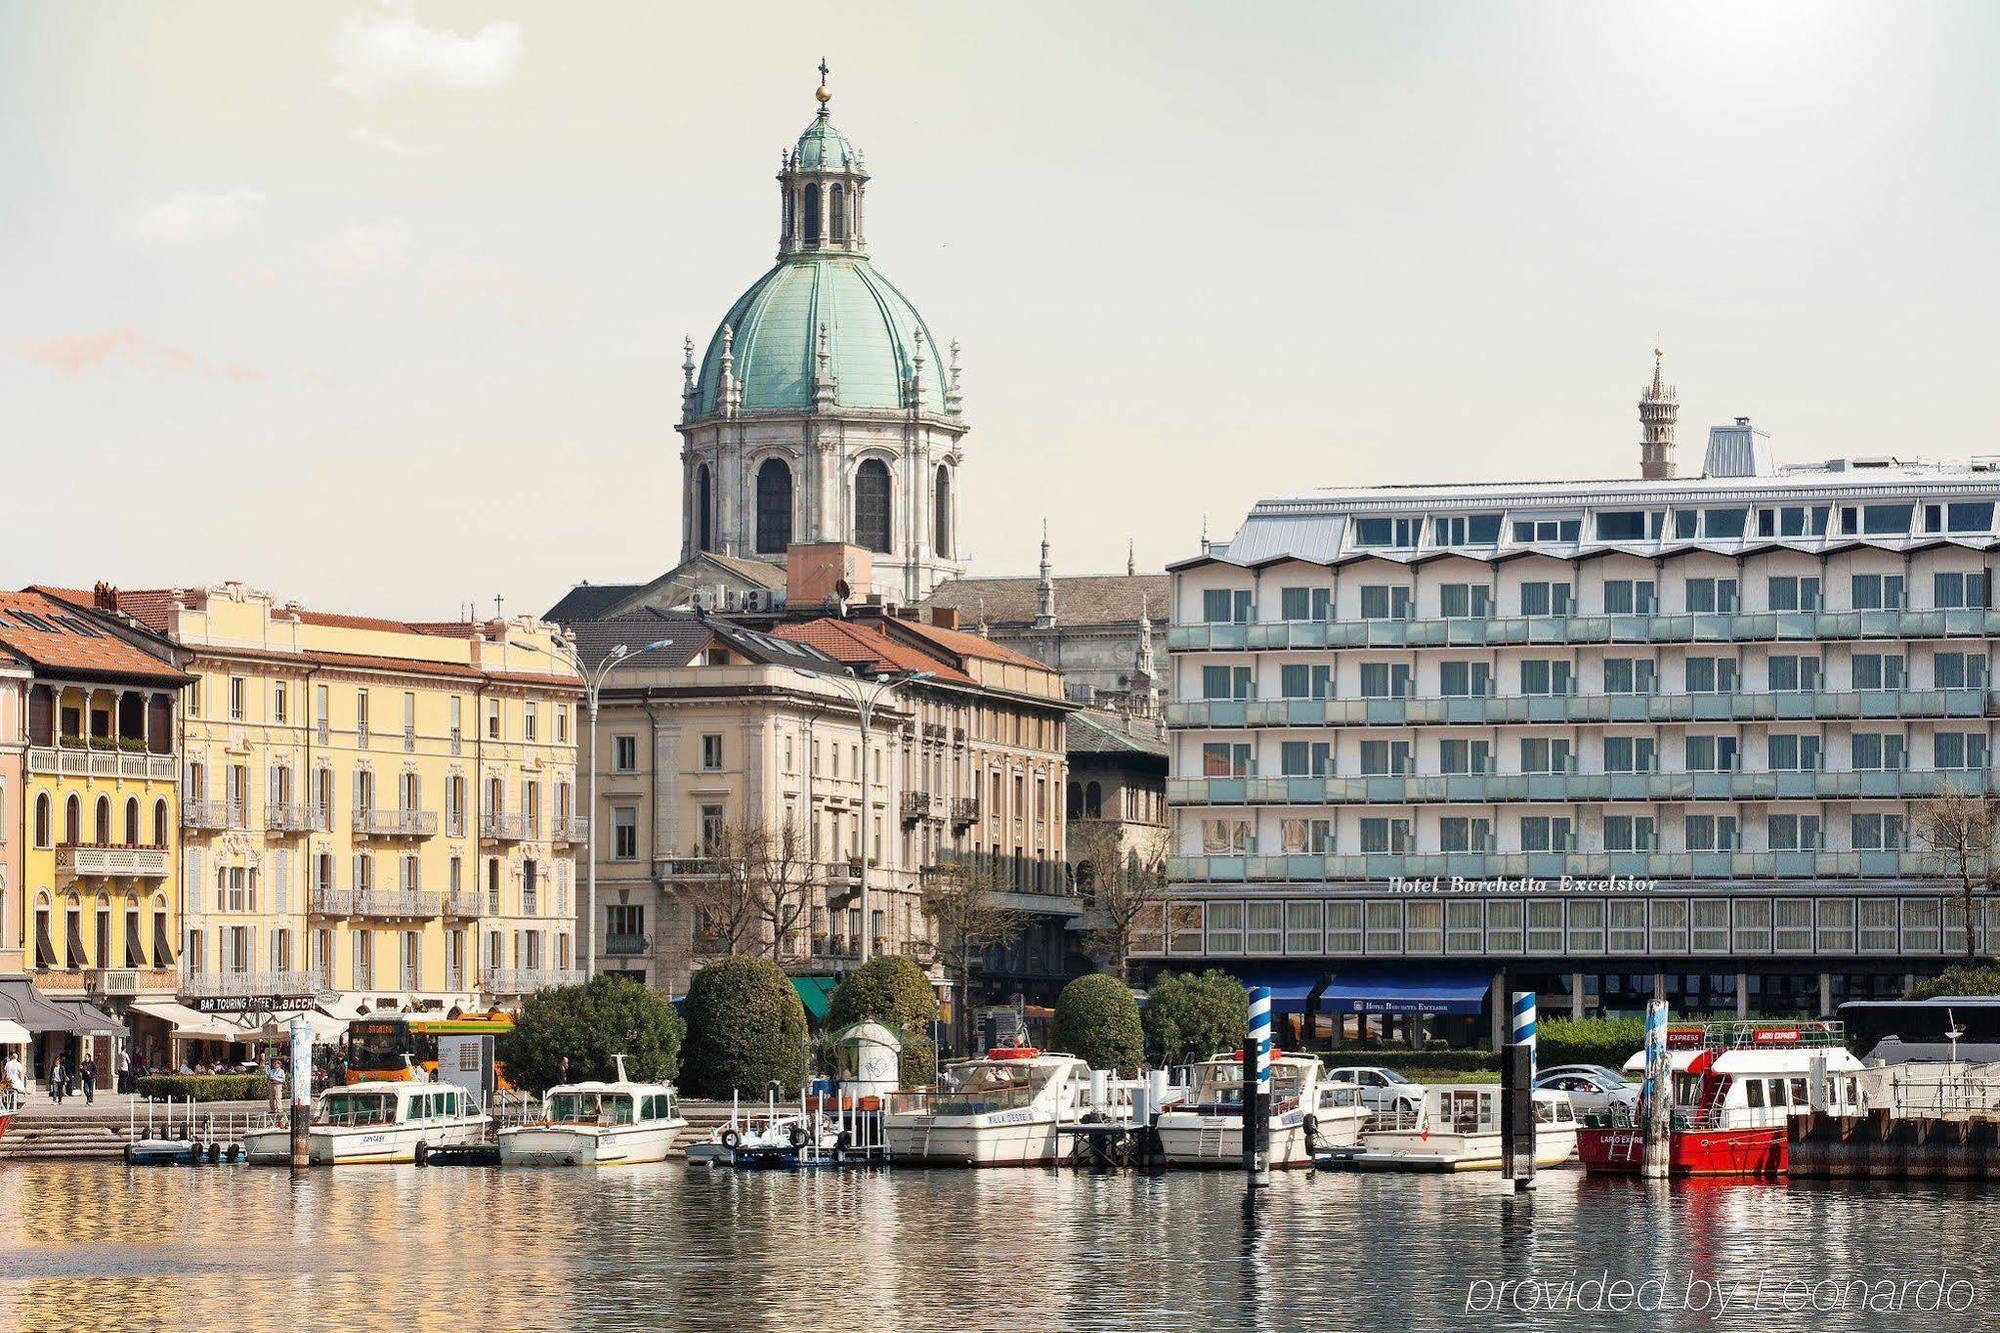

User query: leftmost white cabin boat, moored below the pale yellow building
[244,1081,492,1167]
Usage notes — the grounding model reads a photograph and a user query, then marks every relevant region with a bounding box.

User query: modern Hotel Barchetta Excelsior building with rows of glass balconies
[1142,374,2000,1015]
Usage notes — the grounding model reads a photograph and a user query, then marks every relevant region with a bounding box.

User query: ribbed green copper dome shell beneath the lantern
[694,254,944,416]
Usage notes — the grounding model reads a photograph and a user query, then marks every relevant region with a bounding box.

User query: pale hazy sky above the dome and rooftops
[0,0,2000,618]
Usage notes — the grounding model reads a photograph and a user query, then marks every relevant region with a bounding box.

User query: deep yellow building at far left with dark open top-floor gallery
[0,590,188,1083]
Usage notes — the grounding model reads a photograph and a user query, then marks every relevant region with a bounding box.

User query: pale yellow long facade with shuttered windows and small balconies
[52,582,586,1009]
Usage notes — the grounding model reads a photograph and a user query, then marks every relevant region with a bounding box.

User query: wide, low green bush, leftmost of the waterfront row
[494,973,686,1093]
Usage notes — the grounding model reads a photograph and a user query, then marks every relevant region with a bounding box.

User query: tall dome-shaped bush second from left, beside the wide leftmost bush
[682,959,806,1097]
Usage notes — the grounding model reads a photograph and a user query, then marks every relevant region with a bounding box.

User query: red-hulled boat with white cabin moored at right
[1576,1023,1864,1179]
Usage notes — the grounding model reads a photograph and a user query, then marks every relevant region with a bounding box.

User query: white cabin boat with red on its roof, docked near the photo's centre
[882,1047,1090,1167]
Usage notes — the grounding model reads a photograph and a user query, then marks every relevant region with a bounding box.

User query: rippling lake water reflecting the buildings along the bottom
[0,1163,2000,1333]
